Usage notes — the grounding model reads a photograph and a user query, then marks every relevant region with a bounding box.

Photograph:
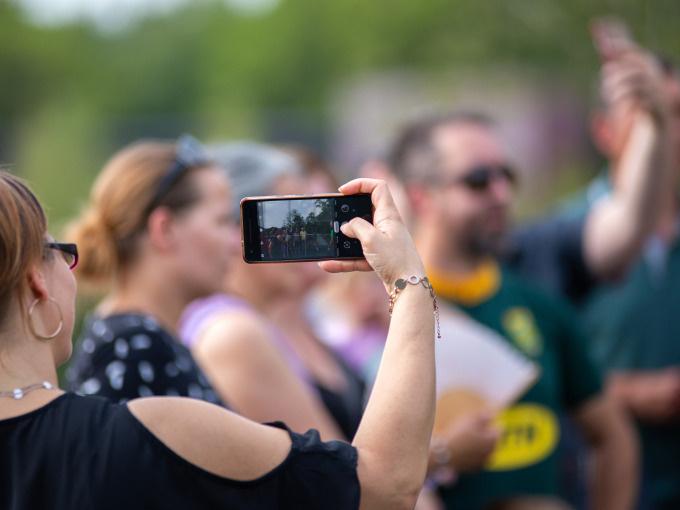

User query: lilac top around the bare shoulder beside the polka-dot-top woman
[179,294,313,387]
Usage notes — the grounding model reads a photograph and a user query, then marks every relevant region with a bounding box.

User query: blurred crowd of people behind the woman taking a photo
[1,15,680,510]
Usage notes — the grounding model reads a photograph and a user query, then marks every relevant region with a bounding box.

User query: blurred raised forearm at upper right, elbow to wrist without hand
[584,111,672,278]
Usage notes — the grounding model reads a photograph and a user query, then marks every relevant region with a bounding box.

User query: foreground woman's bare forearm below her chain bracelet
[354,285,435,508]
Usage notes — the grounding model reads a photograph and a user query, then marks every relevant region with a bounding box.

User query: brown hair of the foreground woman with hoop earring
[0,169,47,324]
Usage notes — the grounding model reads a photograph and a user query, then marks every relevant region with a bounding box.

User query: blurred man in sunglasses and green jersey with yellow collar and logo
[390,109,636,510]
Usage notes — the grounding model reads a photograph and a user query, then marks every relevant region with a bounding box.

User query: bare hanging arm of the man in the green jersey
[574,397,639,510]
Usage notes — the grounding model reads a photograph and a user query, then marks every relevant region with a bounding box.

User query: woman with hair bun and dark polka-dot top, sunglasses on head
[67,137,236,403]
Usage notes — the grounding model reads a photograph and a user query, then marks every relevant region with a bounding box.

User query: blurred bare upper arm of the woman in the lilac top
[193,312,344,441]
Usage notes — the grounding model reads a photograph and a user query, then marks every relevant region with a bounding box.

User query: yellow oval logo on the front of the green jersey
[486,404,560,471]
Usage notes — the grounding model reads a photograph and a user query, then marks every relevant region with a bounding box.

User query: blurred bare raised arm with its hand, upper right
[584,45,673,278]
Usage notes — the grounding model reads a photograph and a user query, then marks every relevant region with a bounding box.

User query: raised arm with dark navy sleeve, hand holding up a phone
[503,18,677,307]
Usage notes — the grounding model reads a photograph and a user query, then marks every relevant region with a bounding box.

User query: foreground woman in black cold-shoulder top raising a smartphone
[0,172,434,510]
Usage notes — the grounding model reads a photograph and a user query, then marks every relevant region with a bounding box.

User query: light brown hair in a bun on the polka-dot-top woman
[66,140,207,286]
